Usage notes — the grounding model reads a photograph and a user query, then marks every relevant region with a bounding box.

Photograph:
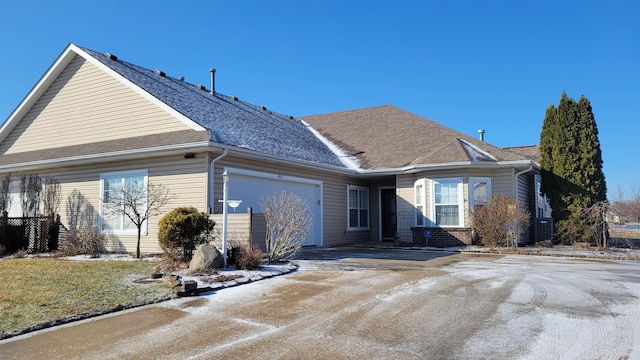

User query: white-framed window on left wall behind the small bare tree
[100,170,148,234]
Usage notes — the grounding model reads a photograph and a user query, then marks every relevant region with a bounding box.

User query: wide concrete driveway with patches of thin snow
[0,248,640,359]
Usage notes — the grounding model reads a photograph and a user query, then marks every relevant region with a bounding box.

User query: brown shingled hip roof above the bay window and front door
[301,105,528,170]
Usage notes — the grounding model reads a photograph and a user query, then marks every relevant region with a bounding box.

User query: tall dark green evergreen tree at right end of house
[540,93,607,241]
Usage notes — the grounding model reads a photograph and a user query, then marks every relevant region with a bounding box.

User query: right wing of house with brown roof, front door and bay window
[302,105,550,246]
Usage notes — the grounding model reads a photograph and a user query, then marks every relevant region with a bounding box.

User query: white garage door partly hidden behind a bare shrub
[226,168,322,246]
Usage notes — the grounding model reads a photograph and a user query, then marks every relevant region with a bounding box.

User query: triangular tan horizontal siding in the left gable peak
[0,56,189,154]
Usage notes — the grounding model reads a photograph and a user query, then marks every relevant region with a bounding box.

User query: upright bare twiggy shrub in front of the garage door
[260,191,313,262]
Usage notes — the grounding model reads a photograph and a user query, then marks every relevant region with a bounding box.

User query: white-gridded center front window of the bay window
[432,178,464,226]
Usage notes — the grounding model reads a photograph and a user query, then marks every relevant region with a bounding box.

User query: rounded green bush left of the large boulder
[158,207,216,261]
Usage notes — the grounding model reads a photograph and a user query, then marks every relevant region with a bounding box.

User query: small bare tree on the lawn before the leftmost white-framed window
[106,181,172,259]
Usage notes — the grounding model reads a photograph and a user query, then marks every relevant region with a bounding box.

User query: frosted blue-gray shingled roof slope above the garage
[82,48,345,168]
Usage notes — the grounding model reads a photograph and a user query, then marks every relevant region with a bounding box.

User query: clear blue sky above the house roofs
[0,0,640,199]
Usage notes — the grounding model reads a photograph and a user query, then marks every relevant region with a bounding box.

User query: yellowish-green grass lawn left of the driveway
[0,258,172,339]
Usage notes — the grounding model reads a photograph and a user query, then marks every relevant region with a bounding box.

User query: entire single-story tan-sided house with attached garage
[0,44,552,253]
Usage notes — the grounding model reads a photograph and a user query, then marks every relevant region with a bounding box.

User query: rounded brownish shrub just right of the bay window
[472,194,530,247]
